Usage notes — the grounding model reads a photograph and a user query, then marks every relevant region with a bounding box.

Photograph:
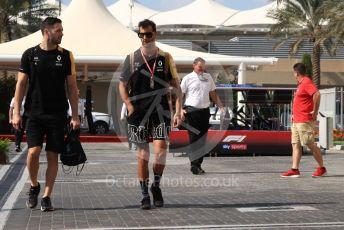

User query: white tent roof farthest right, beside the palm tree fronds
[223,2,277,26]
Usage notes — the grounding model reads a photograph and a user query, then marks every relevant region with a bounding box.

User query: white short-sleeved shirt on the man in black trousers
[180,71,216,109]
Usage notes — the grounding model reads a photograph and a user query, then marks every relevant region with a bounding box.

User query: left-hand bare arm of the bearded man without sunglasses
[12,72,28,129]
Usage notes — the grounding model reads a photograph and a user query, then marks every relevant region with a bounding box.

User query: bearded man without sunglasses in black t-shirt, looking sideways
[12,17,80,211]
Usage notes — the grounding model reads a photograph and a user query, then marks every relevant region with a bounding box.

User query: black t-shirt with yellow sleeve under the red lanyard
[120,49,178,110]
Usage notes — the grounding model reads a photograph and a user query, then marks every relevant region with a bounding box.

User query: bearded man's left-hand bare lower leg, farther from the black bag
[26,146,42,187]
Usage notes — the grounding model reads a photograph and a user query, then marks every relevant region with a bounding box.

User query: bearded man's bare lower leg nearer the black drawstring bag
[43,151,58,197]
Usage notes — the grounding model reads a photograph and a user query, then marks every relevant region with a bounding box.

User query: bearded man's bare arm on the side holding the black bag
[67,74,80,129]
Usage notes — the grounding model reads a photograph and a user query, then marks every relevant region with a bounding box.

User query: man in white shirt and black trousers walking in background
[181,57,224,175]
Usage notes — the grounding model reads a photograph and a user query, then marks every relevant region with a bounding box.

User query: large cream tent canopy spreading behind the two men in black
[0,0,277,69]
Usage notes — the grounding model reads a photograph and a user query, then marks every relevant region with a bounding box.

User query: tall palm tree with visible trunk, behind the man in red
[268,0,333,87]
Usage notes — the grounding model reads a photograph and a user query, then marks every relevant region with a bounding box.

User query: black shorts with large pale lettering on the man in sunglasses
[127,109,171,144]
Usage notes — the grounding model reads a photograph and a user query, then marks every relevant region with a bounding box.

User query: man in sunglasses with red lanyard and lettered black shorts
[119,19,181,209]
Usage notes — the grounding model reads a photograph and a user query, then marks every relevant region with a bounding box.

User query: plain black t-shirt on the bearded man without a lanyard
[19,45,75,117]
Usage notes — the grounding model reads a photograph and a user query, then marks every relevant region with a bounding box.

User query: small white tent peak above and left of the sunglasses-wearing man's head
[108,0,158,28]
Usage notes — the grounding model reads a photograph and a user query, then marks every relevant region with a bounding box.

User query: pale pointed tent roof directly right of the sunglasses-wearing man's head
[151,0,238,27]
